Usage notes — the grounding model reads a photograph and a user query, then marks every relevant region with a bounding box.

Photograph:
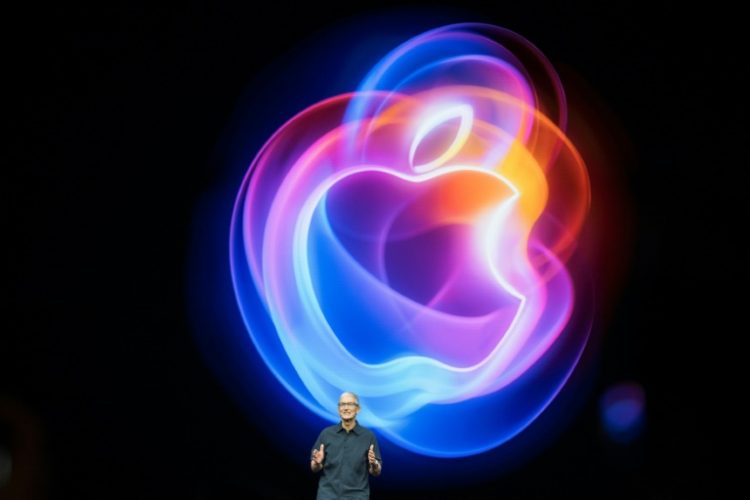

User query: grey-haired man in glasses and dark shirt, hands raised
[310,392,383,500]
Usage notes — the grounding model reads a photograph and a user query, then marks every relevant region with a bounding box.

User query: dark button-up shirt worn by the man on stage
[313,423,382,500]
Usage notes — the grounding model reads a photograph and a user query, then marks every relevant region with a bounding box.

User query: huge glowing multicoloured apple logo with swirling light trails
[230,24,590,457]
